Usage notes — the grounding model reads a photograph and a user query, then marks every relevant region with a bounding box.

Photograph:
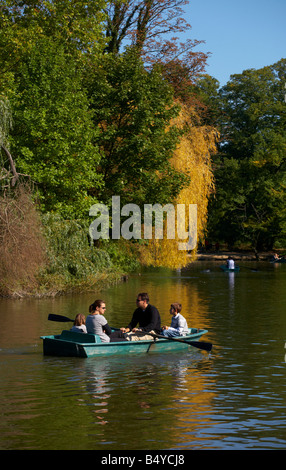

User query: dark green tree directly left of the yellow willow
[91,50,186,204]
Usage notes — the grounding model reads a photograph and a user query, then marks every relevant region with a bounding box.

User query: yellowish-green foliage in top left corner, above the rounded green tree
[0,0,106,59]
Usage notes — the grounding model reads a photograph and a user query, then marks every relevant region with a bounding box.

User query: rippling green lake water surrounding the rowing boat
[0,261,286,451]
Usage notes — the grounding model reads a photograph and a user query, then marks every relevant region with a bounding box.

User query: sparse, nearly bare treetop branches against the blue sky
[106,0,208,93]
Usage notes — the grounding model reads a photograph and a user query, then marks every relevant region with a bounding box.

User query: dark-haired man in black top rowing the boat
[120,292,161,341]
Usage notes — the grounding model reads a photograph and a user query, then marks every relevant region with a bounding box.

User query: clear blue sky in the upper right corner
[184,0,286,86]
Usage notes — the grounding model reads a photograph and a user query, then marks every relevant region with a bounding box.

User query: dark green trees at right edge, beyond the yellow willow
[209,59,286,251]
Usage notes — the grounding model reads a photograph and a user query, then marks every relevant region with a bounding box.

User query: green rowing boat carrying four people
[41,328,210,358]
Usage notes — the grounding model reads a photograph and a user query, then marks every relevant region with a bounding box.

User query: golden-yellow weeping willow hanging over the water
[141,105,218,269]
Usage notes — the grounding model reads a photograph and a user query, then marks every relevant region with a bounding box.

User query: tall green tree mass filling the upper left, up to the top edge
[0,0,106,217]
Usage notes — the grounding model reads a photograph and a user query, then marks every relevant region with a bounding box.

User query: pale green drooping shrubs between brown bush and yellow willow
[40,213,138,295]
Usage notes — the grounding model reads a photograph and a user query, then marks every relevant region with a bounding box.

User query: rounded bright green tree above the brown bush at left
[12,37,100,217]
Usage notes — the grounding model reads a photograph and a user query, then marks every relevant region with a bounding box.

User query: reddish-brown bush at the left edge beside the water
[0,184,45,297]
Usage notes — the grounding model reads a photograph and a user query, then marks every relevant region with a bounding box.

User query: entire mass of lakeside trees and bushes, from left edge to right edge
[0,0,286,297]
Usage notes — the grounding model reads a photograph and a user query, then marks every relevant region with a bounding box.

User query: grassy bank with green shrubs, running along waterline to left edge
[0,214,140,298]
